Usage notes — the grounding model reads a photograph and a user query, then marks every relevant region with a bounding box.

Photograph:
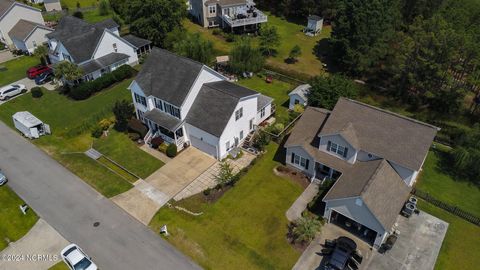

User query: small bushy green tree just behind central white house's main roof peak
[173,33,213,64]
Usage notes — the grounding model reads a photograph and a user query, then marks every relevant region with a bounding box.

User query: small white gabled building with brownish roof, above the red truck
[8,20,53,54]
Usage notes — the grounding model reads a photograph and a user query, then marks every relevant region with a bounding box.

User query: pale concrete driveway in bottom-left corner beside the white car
[0,219,68,270]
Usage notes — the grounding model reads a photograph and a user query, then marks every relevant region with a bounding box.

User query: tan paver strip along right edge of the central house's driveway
[173,151,255,201]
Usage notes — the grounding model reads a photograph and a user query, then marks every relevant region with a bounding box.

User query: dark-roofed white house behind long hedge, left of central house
[47,16,144,81]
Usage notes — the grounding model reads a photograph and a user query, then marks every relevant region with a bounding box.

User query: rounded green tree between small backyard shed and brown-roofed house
[307,75,358,110]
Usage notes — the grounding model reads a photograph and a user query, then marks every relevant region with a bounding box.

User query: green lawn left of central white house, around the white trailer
[0,80,132,197]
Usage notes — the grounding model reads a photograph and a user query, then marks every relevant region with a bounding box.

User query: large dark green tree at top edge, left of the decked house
[126,0,186,48]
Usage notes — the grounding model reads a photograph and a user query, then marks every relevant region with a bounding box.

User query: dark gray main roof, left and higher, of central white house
[135,47,203,107]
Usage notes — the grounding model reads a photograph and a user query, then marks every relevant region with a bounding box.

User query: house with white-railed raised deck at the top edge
[190,0,268,30]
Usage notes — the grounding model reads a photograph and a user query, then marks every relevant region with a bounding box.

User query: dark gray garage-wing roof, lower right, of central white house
[186,81,258,137]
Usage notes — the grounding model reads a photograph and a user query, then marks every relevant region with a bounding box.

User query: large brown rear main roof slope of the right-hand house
[319,98,439,171]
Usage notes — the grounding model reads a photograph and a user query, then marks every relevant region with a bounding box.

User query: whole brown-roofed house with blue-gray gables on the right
[285,98,439,248]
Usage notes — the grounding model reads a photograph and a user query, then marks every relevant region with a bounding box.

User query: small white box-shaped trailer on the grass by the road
[12,111,50,139]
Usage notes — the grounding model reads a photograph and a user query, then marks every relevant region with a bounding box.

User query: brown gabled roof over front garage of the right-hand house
[323,159,410,231]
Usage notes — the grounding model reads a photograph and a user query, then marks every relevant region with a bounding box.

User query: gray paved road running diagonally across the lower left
[0,122,200,270]
